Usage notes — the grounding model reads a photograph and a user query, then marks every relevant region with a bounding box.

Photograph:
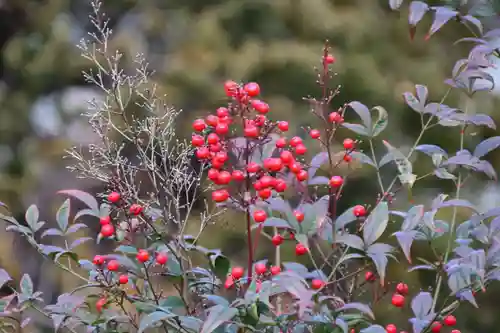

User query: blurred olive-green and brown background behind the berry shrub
[0,0,500,332]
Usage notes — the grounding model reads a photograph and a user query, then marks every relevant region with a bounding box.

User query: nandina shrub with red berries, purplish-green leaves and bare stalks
[0,1,500,333]
